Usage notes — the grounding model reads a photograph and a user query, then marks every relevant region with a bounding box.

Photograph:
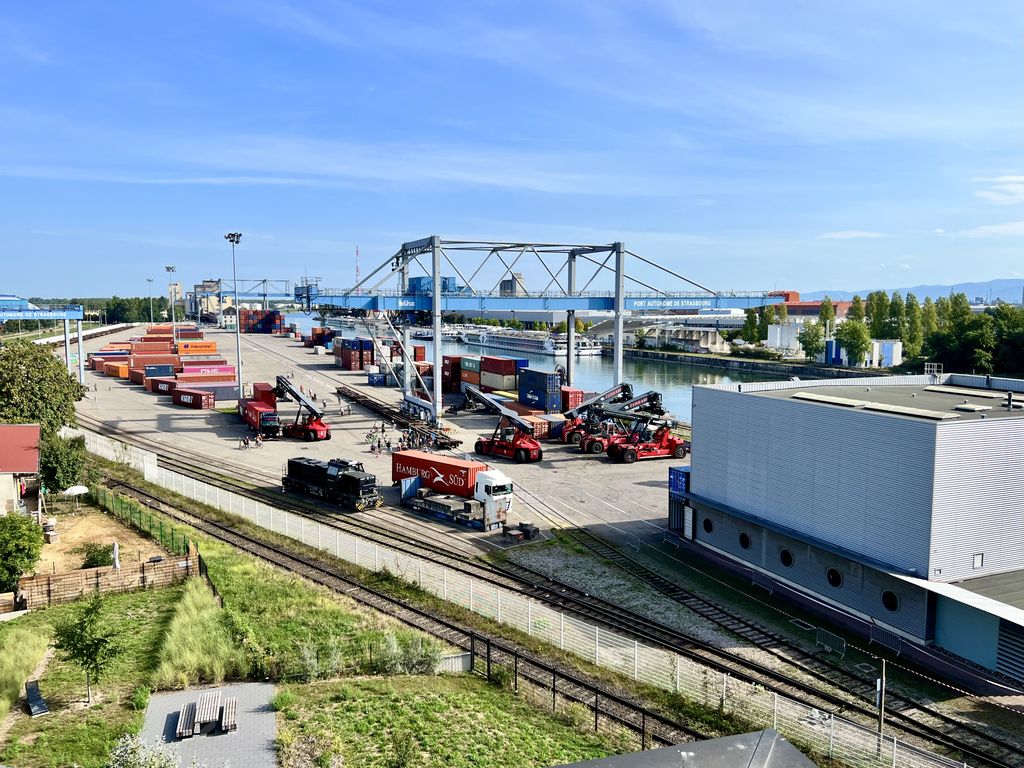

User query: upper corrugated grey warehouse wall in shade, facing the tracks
[691,386,936,577]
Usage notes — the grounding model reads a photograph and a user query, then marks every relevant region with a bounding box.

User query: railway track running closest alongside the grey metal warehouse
[518,485,1024,766]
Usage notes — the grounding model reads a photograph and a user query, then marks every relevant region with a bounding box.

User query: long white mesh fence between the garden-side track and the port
[79,432,965,768]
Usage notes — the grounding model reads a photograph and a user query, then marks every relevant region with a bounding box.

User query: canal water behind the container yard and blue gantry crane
[285,314,778,421]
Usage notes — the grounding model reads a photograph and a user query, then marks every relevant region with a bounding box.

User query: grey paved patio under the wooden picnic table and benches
[141,683,278,768]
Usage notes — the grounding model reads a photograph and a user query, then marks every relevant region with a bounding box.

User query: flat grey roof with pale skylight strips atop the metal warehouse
[744,379,1024,422]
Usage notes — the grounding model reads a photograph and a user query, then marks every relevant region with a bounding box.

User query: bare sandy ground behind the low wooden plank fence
[36,507,167,573]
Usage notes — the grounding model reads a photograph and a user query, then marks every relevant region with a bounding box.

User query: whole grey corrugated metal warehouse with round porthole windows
[670,374,1024,681]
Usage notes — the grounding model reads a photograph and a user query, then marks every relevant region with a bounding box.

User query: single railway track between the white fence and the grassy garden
[109,480,707,748]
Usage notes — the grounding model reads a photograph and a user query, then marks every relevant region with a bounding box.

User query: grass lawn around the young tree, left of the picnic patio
[0,587,182,768]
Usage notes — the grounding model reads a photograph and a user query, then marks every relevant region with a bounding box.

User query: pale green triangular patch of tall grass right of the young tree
[152,579,248,688]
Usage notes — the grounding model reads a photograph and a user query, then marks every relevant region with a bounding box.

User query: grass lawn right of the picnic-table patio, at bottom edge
[278,677,617,768]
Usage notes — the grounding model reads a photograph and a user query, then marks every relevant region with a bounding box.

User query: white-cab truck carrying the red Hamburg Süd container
[391,451,512,530]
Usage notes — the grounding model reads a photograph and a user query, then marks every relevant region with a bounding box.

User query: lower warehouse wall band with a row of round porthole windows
[691,502,931,641]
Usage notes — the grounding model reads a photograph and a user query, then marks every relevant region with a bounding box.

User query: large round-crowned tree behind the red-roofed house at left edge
[0,340,85,438]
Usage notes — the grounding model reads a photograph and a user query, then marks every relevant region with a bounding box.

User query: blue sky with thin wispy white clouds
[0,0,1024,296]
